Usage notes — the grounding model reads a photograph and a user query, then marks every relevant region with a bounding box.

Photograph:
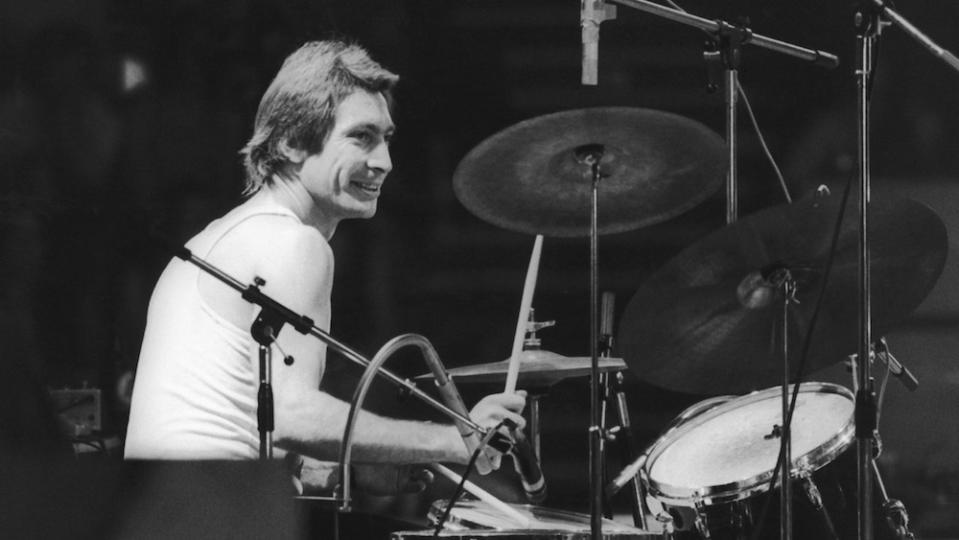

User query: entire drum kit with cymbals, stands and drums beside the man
[393,4,948,540]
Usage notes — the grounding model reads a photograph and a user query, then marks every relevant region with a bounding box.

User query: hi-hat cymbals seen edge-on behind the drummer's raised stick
[416,350,626,387]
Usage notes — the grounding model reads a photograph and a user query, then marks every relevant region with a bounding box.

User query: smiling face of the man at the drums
[299,90,394,221]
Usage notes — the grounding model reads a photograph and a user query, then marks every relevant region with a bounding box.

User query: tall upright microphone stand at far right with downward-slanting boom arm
[855,0,959,540]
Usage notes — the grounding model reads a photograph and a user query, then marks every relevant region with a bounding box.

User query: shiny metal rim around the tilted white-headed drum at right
[640,382,855,508]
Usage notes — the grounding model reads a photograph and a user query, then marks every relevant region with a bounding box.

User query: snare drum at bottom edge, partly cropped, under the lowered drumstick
[392,501,662,540]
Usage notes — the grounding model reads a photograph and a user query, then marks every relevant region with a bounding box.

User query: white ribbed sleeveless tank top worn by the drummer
[124,206,297,459]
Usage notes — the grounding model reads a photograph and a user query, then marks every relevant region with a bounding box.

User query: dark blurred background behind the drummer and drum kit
[0,0,959,537]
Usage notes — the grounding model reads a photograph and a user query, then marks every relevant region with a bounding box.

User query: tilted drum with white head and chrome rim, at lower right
[640,383,856,540]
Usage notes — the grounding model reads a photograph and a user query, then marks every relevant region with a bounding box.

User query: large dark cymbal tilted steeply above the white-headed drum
[618,188,948,394]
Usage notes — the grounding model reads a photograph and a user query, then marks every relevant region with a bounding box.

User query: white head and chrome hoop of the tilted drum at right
[644,383,854,506]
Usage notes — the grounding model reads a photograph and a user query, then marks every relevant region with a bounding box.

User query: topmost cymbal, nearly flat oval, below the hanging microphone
[453,107,726,237]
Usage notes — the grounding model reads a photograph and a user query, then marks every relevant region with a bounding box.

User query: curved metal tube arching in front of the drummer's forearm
[340,334,479,511]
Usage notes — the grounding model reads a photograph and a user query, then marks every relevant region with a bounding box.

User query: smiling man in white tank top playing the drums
[125,37,525,493]
